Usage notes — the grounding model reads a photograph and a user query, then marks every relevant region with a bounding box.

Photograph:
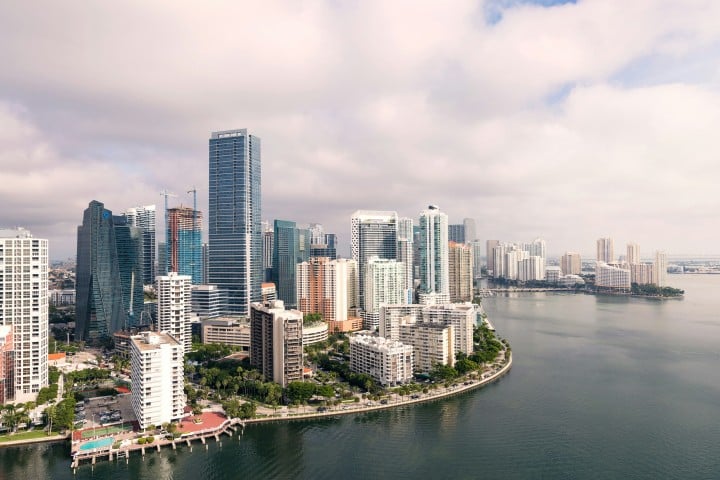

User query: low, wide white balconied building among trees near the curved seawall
[350,335,414,386]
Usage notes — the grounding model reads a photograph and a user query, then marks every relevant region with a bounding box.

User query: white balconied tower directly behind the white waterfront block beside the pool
[157,272,192,352]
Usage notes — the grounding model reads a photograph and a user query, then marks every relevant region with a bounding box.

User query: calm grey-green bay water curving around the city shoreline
[0,276,720,480]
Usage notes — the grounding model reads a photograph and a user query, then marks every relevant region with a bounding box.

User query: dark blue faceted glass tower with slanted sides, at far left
[75,200,127,341]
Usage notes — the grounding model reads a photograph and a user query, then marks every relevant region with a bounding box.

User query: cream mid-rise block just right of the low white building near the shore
[399,322,455,373]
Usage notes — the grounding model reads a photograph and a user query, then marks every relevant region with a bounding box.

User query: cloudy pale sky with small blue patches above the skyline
[0,0,720,259]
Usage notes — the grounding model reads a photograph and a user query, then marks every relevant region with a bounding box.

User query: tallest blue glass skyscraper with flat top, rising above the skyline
[208,129,263,315]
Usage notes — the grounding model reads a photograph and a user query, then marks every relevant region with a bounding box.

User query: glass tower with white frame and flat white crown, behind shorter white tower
[350,210,398,308]
